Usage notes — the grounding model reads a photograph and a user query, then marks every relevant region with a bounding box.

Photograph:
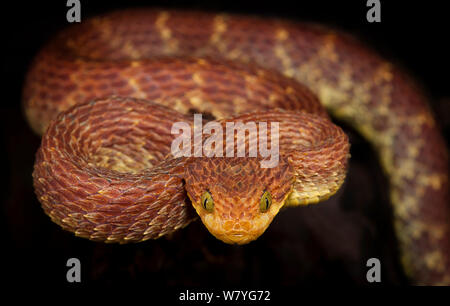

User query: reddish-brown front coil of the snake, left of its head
[33,98,199,242]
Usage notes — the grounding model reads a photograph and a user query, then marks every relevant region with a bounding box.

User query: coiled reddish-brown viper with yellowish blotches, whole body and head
[22,9,450,285]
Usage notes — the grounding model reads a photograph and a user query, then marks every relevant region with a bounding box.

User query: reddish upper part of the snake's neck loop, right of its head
[220,110,349,200]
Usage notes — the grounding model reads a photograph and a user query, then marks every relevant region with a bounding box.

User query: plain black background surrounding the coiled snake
[0,0,450,293]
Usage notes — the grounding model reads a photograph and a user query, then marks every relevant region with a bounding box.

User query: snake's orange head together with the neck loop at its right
[183,110,349,244]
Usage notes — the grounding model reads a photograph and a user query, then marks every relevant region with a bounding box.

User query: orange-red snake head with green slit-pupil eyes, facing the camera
[185,157,294,244]
